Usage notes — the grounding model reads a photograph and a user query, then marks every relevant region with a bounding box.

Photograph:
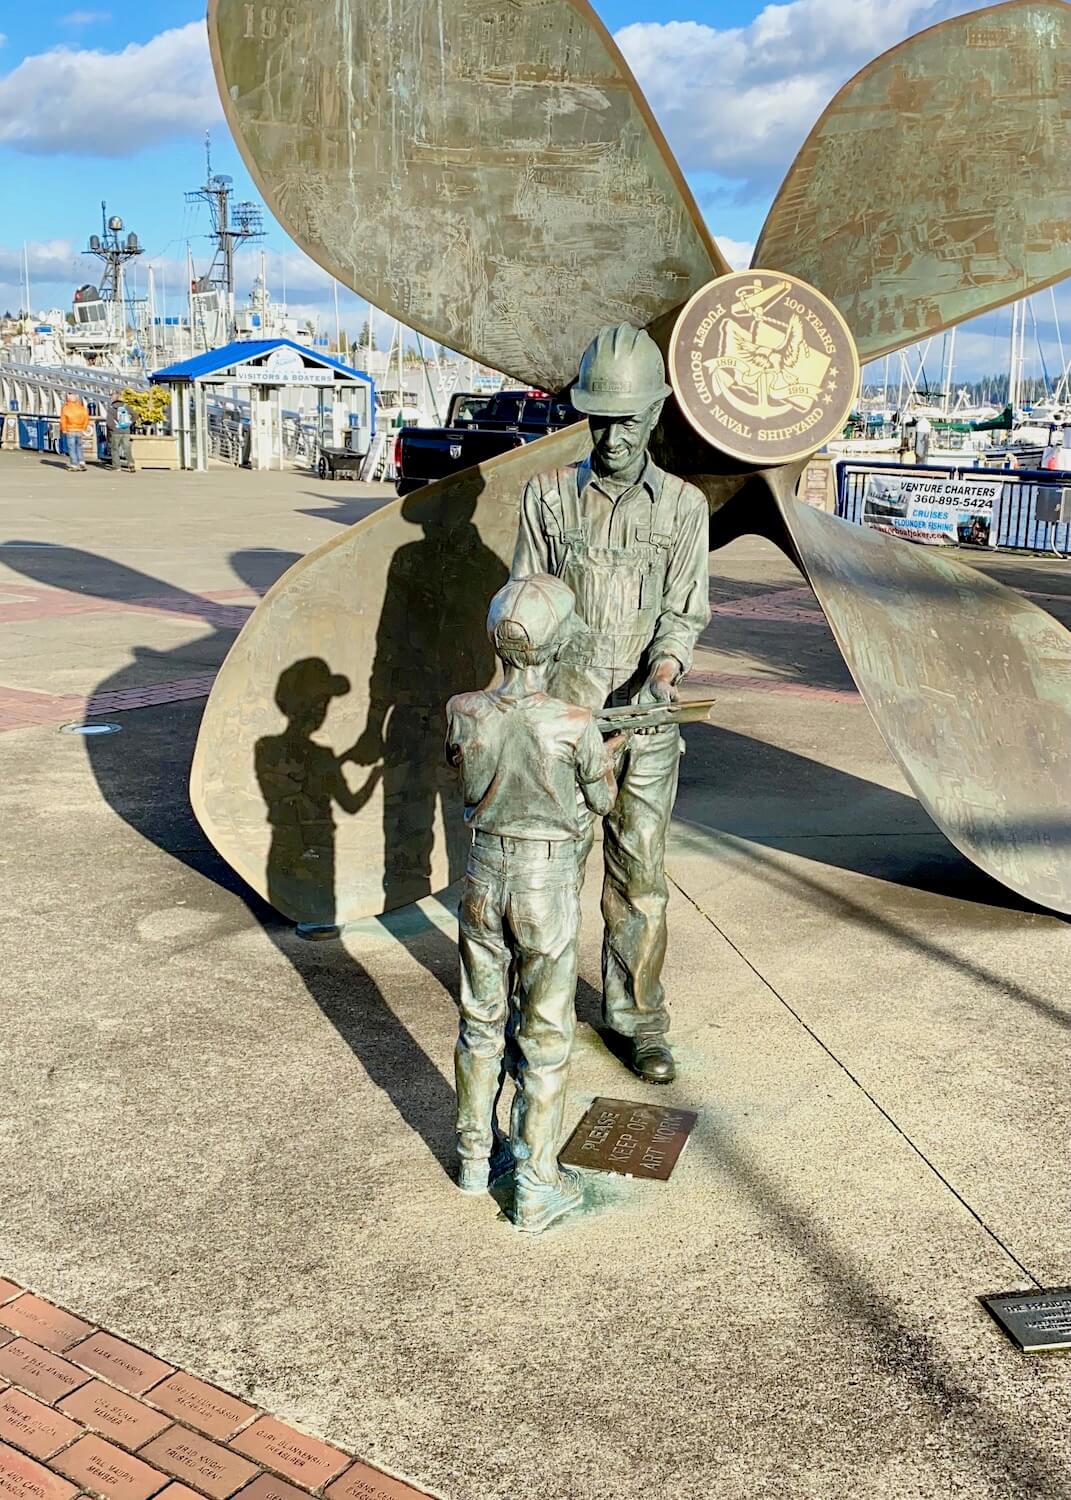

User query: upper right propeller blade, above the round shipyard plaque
[755,0,1071,363]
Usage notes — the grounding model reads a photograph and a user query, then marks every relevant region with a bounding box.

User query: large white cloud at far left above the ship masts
[0,21,222,156]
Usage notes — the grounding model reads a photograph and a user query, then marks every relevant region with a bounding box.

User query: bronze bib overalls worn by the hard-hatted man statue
[531,468,683,1037]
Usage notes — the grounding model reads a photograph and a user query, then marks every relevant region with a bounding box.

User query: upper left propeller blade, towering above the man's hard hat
[209,0,728,390]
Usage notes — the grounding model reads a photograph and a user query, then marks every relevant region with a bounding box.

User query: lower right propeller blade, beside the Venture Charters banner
[767,467,1071,914]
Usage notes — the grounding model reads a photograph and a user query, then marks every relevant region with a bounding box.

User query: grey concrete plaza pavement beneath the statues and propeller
[0,453,1071,1500]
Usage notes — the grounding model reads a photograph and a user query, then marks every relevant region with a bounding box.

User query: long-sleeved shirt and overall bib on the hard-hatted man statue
[512,456,710,707]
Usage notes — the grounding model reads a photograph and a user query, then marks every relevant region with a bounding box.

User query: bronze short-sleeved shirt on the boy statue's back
[446,693,608,840]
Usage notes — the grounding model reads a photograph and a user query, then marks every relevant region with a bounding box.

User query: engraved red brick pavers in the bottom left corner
[0,1278,425,1500]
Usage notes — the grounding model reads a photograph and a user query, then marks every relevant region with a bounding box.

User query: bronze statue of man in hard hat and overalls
[512,323,710,1083]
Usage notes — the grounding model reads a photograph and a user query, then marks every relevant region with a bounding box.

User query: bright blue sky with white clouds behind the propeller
[0,0,1071,381]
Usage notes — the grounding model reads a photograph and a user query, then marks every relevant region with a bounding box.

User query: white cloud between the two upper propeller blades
[615,0,974,198]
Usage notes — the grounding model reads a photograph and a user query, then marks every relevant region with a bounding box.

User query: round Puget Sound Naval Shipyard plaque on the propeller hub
[669,272,860,467]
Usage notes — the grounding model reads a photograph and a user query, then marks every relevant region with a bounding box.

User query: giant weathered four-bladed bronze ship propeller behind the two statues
[191,0,1071,923]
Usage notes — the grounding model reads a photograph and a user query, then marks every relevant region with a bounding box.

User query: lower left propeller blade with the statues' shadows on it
[191,423,590,924]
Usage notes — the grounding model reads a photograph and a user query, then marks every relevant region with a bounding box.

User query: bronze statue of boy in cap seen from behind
[447,573,623,1233]
